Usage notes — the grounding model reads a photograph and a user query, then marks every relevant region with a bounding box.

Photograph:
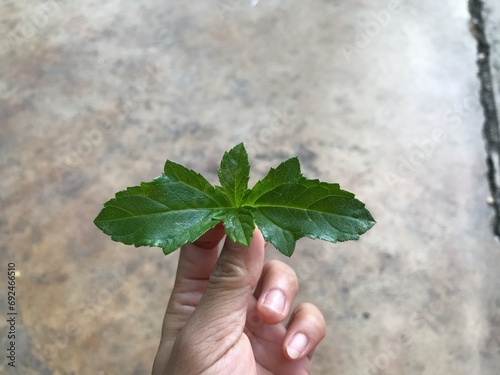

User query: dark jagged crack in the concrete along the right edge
[469,0,500,237]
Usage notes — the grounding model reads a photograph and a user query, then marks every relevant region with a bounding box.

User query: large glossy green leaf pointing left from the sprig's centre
[94,161,230,254]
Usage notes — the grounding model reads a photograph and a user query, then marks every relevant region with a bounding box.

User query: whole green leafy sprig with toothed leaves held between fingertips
[94,144,375,256]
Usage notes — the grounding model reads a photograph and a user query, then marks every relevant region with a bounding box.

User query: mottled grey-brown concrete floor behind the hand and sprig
[0,0,500,375]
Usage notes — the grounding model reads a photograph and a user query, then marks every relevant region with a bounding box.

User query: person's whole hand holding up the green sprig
[153,225,326,375]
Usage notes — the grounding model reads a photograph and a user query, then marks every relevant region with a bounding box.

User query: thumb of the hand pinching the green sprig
[183,229,265,352]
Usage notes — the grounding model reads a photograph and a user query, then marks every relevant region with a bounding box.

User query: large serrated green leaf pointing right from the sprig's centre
[245,158,375,256]
